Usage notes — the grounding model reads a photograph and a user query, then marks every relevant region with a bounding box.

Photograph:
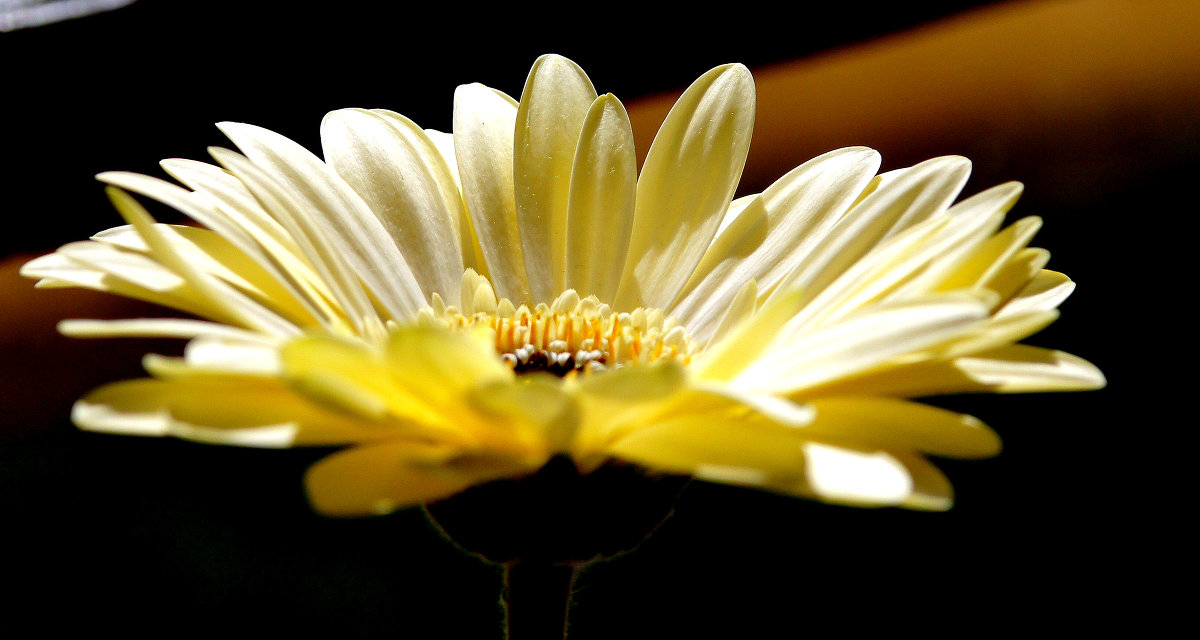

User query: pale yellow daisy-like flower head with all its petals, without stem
[23,55,1104,515]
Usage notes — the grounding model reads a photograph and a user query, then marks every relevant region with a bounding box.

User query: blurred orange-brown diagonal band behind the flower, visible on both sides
[0,0,1200,437]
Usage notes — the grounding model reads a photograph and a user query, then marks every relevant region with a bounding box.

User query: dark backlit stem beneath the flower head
[503,560,576,640]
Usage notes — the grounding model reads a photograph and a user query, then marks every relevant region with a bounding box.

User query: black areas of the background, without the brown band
[0,0,1180,639]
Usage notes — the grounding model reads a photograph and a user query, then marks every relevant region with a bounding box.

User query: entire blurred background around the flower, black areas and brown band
[0,0,1200,639]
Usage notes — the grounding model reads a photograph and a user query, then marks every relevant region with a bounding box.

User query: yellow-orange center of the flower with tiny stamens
[419,270,695,376]
